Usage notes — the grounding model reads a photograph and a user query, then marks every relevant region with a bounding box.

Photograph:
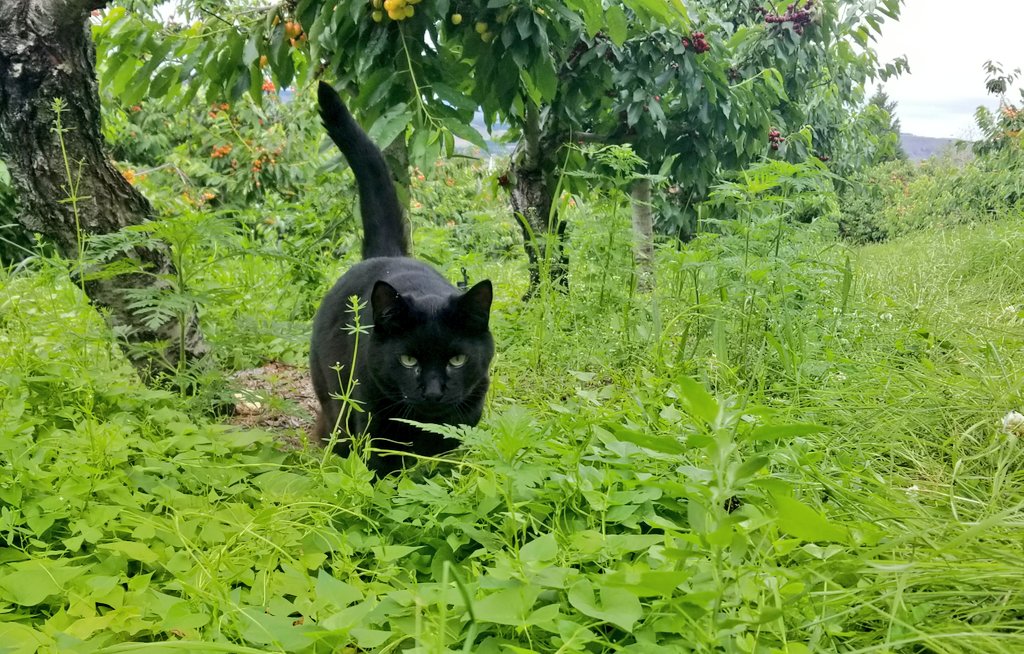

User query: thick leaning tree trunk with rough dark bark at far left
[0,0,206,378]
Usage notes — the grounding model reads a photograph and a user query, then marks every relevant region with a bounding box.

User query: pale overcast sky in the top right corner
[877,0,1024,138]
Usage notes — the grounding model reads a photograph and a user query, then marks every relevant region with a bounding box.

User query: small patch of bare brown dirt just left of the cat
[227,362,319,446]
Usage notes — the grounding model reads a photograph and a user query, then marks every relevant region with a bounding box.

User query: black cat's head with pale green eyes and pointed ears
[370,281,495,422]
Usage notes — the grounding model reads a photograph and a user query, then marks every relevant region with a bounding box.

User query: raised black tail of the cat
[316,82,409,259]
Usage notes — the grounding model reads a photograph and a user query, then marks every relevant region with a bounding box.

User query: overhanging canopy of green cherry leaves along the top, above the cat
[95,0,905,240]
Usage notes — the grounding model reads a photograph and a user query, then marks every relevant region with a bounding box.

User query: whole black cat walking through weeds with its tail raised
[309,82,495,475]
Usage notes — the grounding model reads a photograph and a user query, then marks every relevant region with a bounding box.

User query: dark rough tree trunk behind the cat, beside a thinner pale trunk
[510,101,569,300]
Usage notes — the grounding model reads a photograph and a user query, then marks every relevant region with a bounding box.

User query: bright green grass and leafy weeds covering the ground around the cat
[0,195,1024,653]
